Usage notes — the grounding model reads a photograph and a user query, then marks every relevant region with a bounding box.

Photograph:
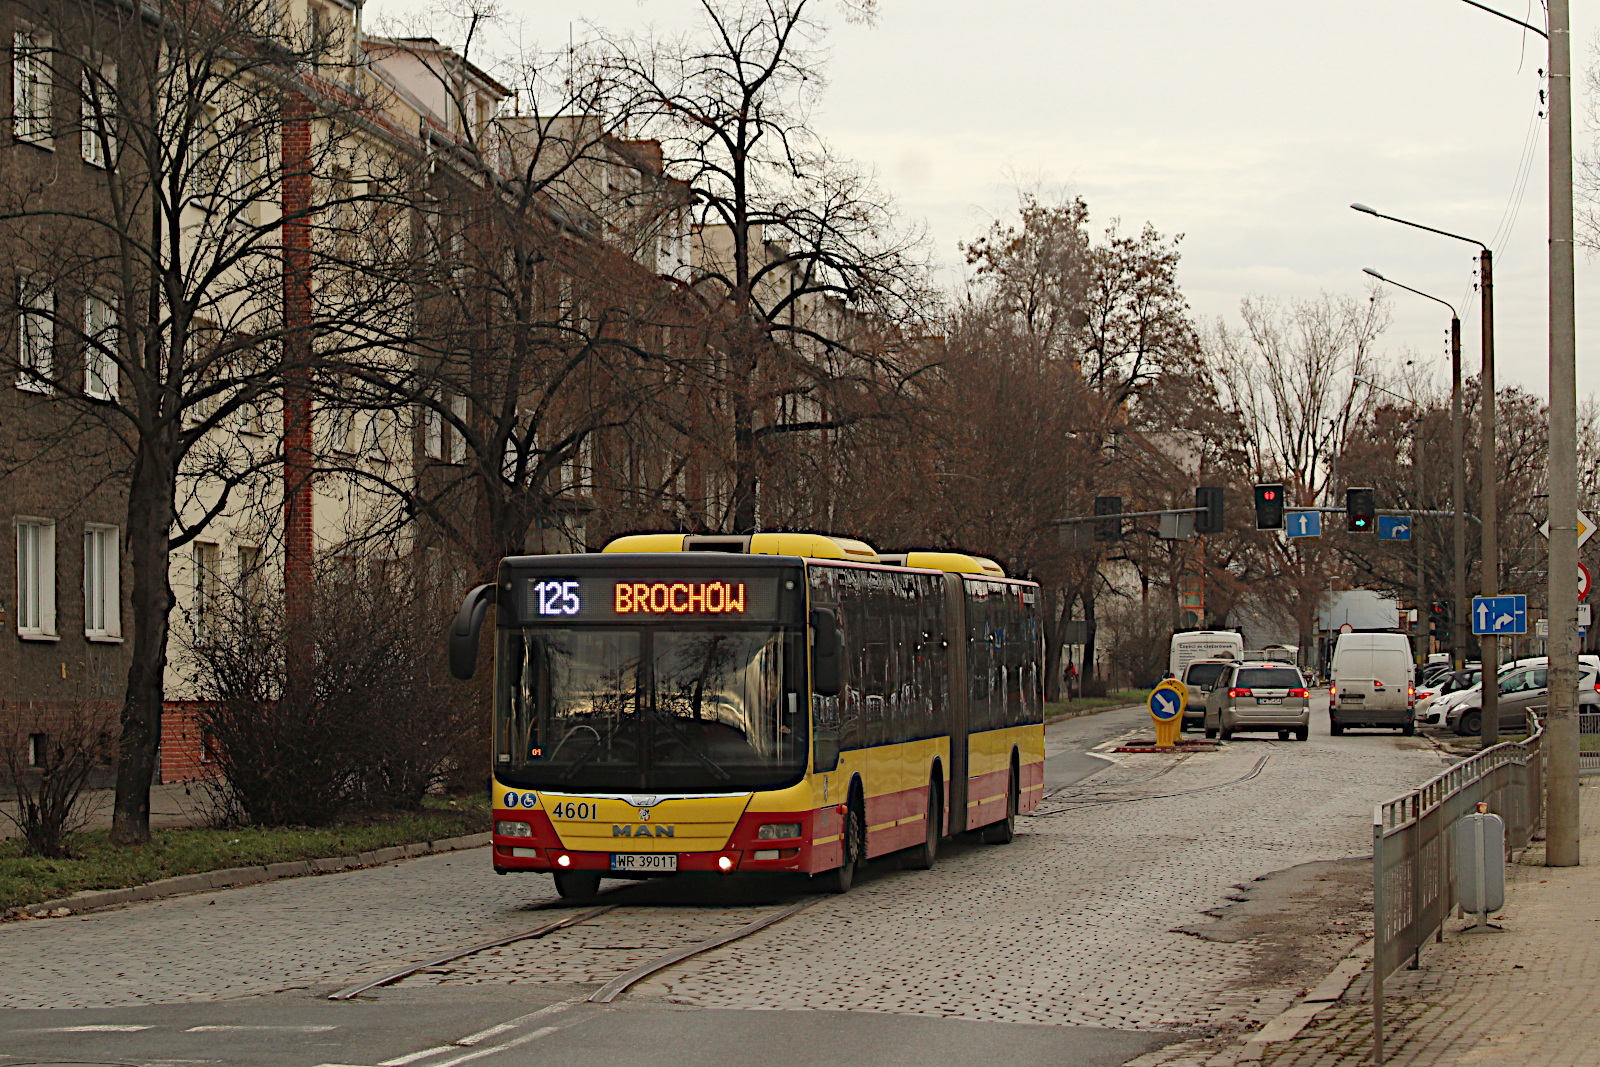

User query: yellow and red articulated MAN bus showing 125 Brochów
[450,533,1045,897]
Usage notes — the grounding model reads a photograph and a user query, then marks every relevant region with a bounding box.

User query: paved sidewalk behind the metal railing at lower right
[1261,779,1600,1067]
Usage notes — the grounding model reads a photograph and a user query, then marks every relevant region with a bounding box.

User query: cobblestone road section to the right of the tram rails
[638,717,1440,1030]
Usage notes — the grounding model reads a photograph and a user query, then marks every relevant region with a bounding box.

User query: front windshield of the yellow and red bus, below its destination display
[494,627,808,793]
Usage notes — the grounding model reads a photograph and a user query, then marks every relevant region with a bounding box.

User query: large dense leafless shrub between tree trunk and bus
[194,561,470,825]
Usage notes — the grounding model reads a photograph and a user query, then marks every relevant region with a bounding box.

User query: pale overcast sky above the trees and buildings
[377,0,1600,394]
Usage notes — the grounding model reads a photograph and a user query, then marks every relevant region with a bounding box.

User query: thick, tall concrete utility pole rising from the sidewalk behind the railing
[1544,0,1579,867]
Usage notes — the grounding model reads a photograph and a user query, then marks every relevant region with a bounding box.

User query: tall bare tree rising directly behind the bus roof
[610,0,925,531]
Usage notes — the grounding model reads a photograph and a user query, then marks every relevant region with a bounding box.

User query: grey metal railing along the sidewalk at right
[1373,715,1542,1064]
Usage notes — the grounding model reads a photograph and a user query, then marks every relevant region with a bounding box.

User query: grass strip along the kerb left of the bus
[0,795,490,910]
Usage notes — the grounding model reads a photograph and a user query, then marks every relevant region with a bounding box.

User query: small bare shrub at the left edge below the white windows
[0,701,117,857]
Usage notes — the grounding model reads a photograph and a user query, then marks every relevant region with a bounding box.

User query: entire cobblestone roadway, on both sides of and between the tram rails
[0,700,1440,1049]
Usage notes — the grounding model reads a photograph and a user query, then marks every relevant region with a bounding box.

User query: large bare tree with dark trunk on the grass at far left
[0,0,403,843]
